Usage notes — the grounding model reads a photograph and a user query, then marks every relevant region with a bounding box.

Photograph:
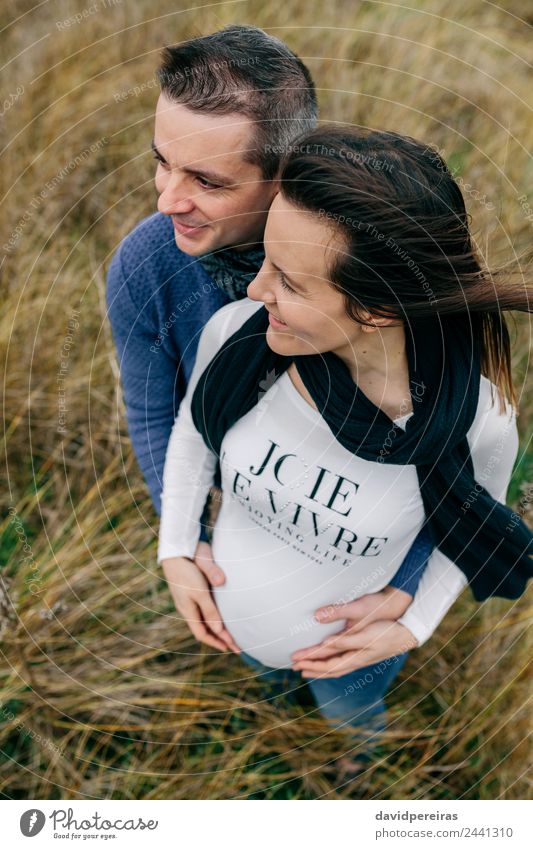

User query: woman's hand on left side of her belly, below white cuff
[161,543,240,653]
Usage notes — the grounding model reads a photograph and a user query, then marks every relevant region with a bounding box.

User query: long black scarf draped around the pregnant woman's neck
[192,308,533,601]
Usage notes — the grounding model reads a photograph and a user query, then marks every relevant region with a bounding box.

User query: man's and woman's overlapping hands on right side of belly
[292,587,418,678]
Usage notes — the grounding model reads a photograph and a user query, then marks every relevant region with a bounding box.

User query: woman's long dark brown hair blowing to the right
[281,126,531,409]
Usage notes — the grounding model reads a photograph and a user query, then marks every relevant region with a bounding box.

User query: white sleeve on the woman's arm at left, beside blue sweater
[157,303,247,563]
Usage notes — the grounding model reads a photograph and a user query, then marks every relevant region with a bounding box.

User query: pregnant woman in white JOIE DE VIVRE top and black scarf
[158,127,532,756]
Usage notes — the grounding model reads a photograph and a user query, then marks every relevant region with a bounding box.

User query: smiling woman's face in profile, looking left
[247,194,361,360]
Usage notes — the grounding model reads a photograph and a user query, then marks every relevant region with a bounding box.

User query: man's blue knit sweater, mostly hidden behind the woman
[107,213,432,595]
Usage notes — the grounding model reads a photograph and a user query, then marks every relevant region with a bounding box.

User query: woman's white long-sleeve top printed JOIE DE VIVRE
[158,298,518,667]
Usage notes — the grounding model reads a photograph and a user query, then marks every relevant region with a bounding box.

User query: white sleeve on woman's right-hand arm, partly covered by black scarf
[398,388,518,645]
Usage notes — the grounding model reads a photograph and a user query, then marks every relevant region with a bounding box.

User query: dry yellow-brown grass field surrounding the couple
[0,0,533,799]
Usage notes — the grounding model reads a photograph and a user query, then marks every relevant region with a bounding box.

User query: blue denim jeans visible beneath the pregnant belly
[239,652,408,734]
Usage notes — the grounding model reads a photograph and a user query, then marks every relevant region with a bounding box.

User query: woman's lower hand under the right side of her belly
[292,620,418,678]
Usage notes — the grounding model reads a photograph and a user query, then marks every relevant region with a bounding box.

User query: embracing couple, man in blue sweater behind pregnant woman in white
[108,26,532,768]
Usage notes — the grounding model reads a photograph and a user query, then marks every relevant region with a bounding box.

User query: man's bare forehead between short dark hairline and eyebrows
[154,95,257,171]
